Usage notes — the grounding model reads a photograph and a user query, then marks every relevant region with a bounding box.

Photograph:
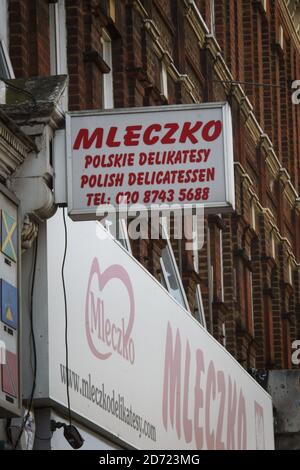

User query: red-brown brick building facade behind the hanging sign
[9,0,300,369]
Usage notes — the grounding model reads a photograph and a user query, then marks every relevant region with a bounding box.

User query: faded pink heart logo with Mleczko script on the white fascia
[85,258,135,364]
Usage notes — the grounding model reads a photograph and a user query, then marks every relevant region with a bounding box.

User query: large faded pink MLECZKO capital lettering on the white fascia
[162,323,253,450]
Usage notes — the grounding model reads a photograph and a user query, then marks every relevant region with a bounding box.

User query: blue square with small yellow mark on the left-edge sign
[0,279,18,329]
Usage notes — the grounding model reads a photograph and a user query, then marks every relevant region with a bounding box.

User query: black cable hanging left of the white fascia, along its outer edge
[14,237,38,449]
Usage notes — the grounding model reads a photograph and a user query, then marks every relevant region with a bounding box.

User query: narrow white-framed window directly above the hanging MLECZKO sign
[101,29,114,109]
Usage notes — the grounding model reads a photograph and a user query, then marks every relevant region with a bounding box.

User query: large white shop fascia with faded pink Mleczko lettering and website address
[48,214,274,450]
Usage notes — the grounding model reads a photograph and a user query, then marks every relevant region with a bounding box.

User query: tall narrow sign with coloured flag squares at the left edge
[0,184,22,417]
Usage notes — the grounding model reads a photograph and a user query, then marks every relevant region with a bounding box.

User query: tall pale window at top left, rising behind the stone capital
[49,0,68,109]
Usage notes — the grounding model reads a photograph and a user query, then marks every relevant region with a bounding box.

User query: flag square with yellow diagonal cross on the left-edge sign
[1,211,18,262]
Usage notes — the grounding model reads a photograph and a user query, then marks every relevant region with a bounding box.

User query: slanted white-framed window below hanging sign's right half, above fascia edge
[160,228,190,311]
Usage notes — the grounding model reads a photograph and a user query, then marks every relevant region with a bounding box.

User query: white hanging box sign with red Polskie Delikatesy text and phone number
[66,103,234,220]
